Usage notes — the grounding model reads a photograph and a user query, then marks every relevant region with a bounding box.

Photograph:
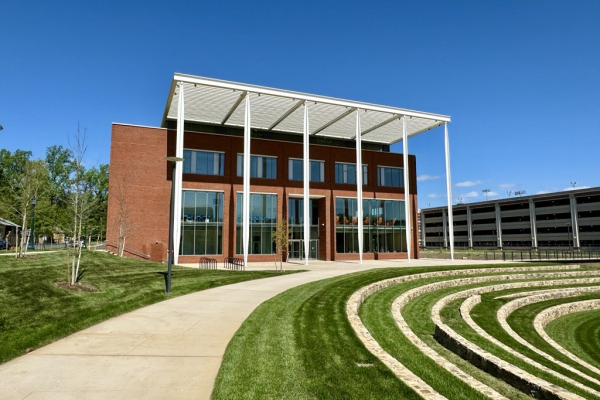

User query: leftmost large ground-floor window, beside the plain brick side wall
[179,190,223,255]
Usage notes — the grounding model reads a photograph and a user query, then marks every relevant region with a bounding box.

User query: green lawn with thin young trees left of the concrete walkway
[0,251,298,363]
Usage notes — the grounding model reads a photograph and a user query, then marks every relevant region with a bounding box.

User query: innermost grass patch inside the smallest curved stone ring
[545,310,600,368]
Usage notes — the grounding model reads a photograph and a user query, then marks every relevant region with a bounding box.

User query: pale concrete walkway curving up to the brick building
[0,260,508,400]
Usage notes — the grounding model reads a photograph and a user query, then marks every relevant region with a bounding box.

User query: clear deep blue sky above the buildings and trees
[0,0,600,207]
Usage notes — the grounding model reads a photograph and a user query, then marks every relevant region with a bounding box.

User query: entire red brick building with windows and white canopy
[107,74,449,263]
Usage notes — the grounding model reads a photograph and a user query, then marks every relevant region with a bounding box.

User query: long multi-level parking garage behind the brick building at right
[420,187,600,249]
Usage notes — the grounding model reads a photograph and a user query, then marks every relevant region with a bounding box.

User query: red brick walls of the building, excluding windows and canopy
[107,124,419,263]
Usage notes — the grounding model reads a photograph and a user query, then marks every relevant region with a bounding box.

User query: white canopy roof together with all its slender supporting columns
[162,73,454,264]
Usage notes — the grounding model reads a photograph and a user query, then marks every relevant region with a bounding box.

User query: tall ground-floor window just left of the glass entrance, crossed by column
[236,193,277,254]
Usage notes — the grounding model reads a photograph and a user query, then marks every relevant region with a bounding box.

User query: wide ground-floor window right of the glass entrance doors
[335,197,406,253]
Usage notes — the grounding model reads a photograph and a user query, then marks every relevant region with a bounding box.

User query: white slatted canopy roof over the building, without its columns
[162,73,450,145]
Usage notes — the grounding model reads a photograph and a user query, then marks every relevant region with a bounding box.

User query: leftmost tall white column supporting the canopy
[171,82,185,264]
